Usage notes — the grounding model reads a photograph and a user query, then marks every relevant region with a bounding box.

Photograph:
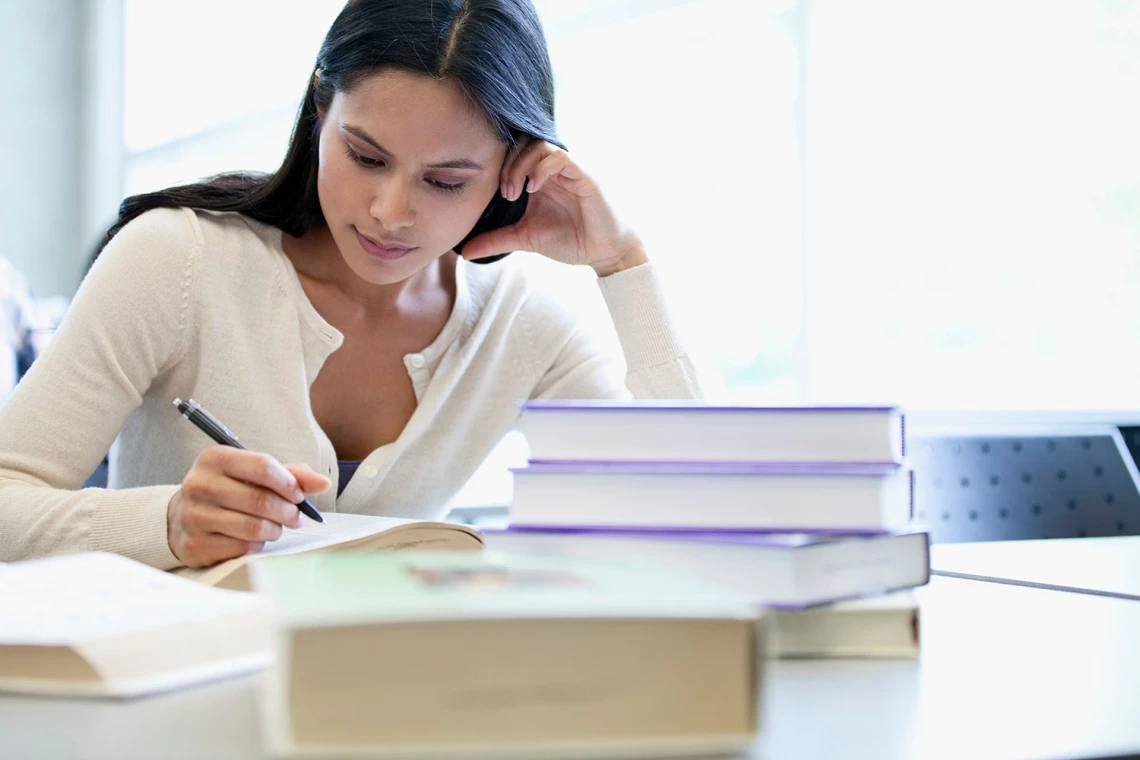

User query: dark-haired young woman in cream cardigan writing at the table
[0,0,699,569]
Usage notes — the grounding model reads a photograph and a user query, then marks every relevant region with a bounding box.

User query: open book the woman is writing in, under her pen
[173,513,483,591]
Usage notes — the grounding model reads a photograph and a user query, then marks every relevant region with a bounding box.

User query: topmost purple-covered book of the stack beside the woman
[520,401,906,464]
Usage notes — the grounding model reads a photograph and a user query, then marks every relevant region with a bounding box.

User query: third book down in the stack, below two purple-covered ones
[483,528,930,610]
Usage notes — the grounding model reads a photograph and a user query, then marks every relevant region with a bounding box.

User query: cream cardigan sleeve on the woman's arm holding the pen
[0,209,201,569]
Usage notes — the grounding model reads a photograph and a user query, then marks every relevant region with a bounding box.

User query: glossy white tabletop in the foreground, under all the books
[0,578,1140,760]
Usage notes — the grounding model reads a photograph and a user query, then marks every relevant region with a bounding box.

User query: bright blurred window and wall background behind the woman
[0,0,1140,410]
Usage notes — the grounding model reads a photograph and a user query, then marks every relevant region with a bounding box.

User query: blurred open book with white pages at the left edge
[0,553,272,697]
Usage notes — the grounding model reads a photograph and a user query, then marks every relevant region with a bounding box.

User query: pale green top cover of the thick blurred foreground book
[253,551,759,628]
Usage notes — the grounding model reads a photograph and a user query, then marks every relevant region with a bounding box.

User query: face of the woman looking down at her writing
[317,70,507,285]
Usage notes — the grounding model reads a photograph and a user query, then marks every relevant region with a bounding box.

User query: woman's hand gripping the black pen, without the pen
[166,446,331,567]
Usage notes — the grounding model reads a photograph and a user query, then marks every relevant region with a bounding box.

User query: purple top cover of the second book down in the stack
[511,459,905,477]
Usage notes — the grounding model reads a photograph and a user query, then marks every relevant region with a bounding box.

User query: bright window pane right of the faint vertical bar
[806,0,1140,409]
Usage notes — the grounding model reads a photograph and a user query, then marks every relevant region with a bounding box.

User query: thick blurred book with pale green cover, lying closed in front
[253,553,764,760]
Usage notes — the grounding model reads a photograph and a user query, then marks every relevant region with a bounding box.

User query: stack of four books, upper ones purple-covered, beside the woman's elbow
[483,401,930,656]
